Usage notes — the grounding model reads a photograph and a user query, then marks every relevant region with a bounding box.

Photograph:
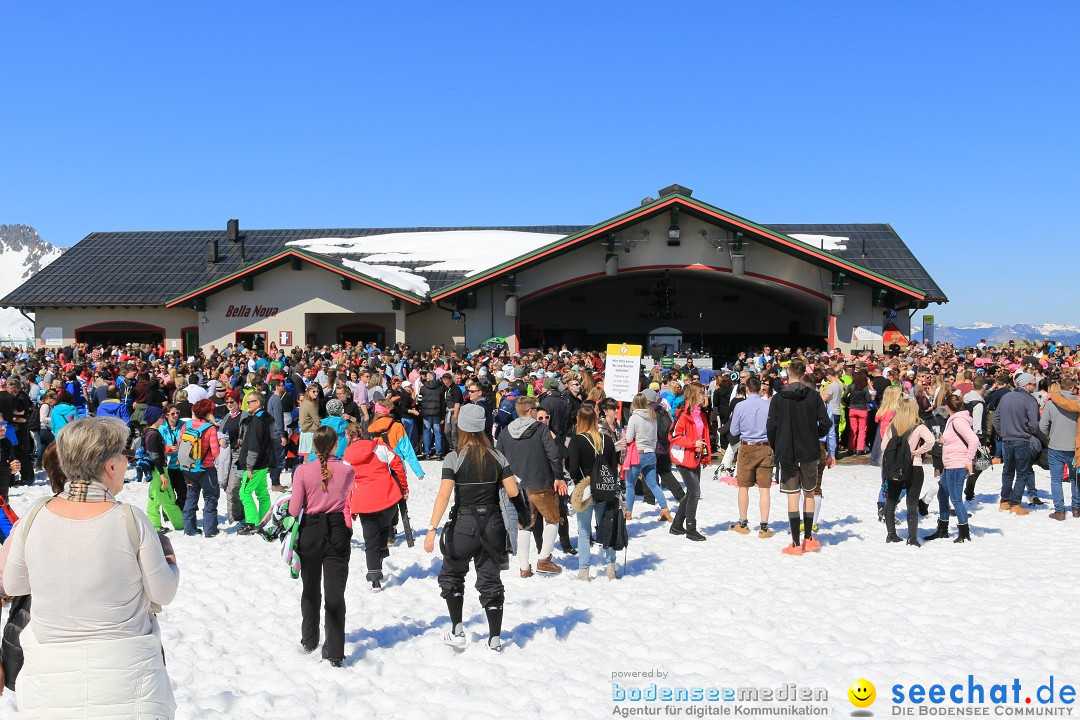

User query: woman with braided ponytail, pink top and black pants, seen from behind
[288,426,354,667]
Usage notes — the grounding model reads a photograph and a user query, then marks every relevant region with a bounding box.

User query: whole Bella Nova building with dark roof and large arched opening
[0,186,947,354]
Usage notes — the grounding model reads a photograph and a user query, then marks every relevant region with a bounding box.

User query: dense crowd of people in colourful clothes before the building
[0,341,1080,707]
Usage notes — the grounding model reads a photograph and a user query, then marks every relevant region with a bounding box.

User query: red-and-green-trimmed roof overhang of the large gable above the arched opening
[431,194,927,303]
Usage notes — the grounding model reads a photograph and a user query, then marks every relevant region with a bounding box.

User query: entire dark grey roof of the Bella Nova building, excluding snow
[0,225,948,308]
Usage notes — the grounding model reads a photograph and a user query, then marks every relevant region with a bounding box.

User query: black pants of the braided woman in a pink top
[296,513,352,660]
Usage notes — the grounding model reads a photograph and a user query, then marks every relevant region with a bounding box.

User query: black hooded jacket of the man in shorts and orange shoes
[766,382,833,463]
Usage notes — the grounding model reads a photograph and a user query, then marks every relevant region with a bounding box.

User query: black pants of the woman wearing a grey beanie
[438,505,507,622]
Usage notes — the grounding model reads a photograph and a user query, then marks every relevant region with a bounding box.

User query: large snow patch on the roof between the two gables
[287,230,565,278]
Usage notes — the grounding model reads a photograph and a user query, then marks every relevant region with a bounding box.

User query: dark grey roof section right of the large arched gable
[762,223,948,302]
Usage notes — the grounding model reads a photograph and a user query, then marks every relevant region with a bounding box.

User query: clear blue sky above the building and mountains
[0,1,1080,325]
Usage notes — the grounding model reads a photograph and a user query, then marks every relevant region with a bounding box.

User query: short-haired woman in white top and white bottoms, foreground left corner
[3,418,179,718]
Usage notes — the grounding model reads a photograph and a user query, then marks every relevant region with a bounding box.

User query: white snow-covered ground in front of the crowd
[0,463,1080,720]
